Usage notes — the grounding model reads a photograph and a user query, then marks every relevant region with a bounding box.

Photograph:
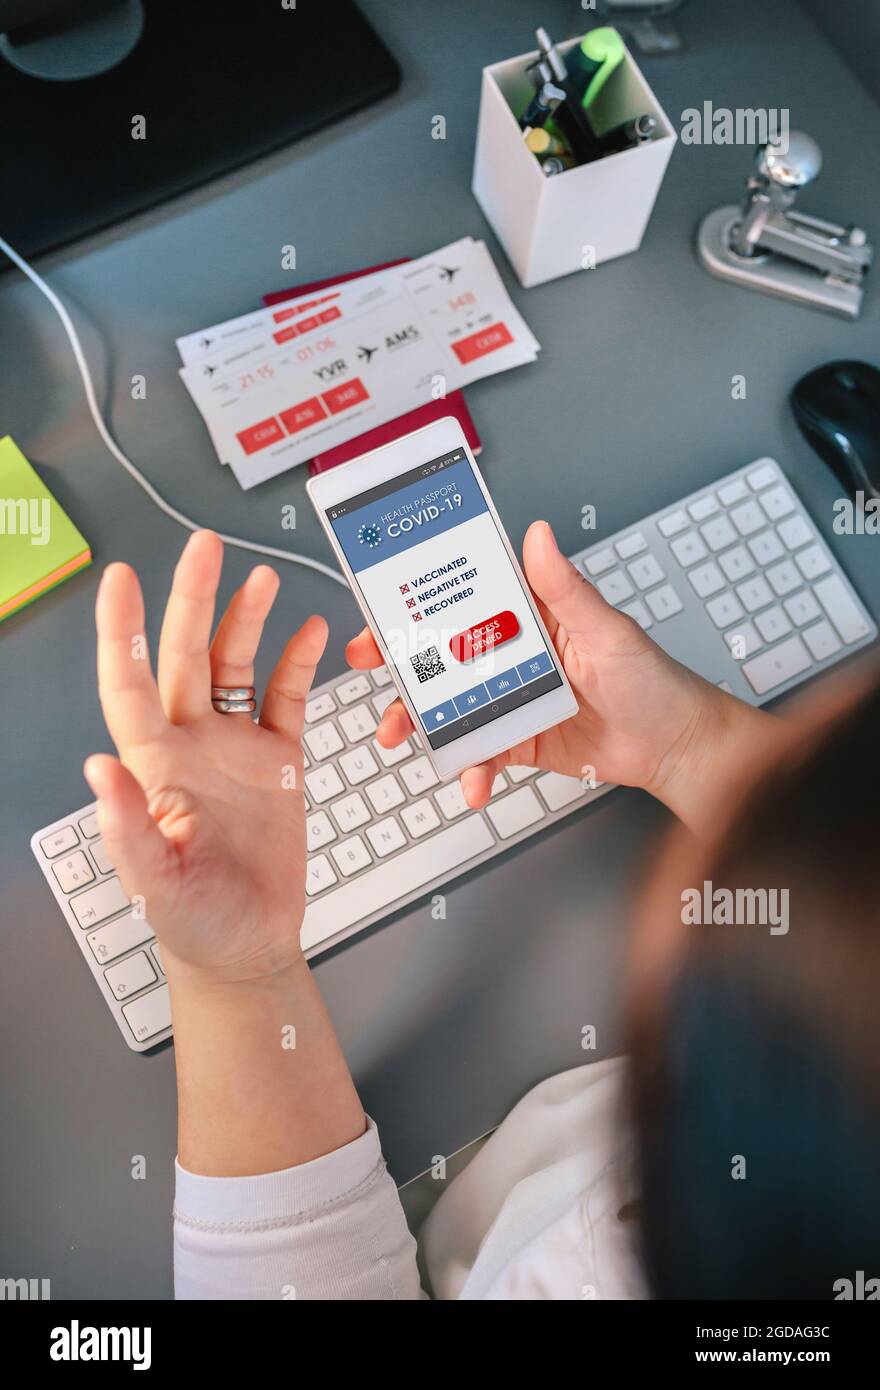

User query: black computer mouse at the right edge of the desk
[791,361,880,498]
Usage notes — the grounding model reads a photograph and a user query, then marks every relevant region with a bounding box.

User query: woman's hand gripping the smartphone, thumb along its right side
[346,521,776,823]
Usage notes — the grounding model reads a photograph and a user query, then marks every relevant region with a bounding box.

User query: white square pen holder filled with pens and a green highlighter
[471,39,677,288]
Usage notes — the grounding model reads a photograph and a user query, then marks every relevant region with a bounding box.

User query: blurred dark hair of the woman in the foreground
[630,672,880,1300]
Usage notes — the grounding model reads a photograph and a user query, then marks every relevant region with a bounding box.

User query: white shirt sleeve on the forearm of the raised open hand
[174,1120,425,1301]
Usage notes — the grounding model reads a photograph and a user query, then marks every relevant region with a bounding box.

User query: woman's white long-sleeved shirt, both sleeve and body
[174,1058,646,1300]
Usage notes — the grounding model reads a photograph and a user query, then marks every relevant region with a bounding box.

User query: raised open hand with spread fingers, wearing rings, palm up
[85,531,327,979]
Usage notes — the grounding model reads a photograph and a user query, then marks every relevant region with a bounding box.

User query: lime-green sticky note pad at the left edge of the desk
[0,435,92,621]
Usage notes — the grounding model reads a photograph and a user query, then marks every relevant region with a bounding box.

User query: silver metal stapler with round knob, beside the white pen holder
[696,131,873,318]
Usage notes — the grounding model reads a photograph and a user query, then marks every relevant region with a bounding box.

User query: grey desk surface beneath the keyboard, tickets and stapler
[0,0,880,1298]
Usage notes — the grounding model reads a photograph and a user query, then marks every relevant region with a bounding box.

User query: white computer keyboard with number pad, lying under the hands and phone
[31,459,877,1052]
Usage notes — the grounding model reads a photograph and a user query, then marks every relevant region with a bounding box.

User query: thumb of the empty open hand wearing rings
[82,753,172,913]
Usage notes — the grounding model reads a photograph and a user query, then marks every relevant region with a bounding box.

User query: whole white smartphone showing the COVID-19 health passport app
[306,417,577,780]
